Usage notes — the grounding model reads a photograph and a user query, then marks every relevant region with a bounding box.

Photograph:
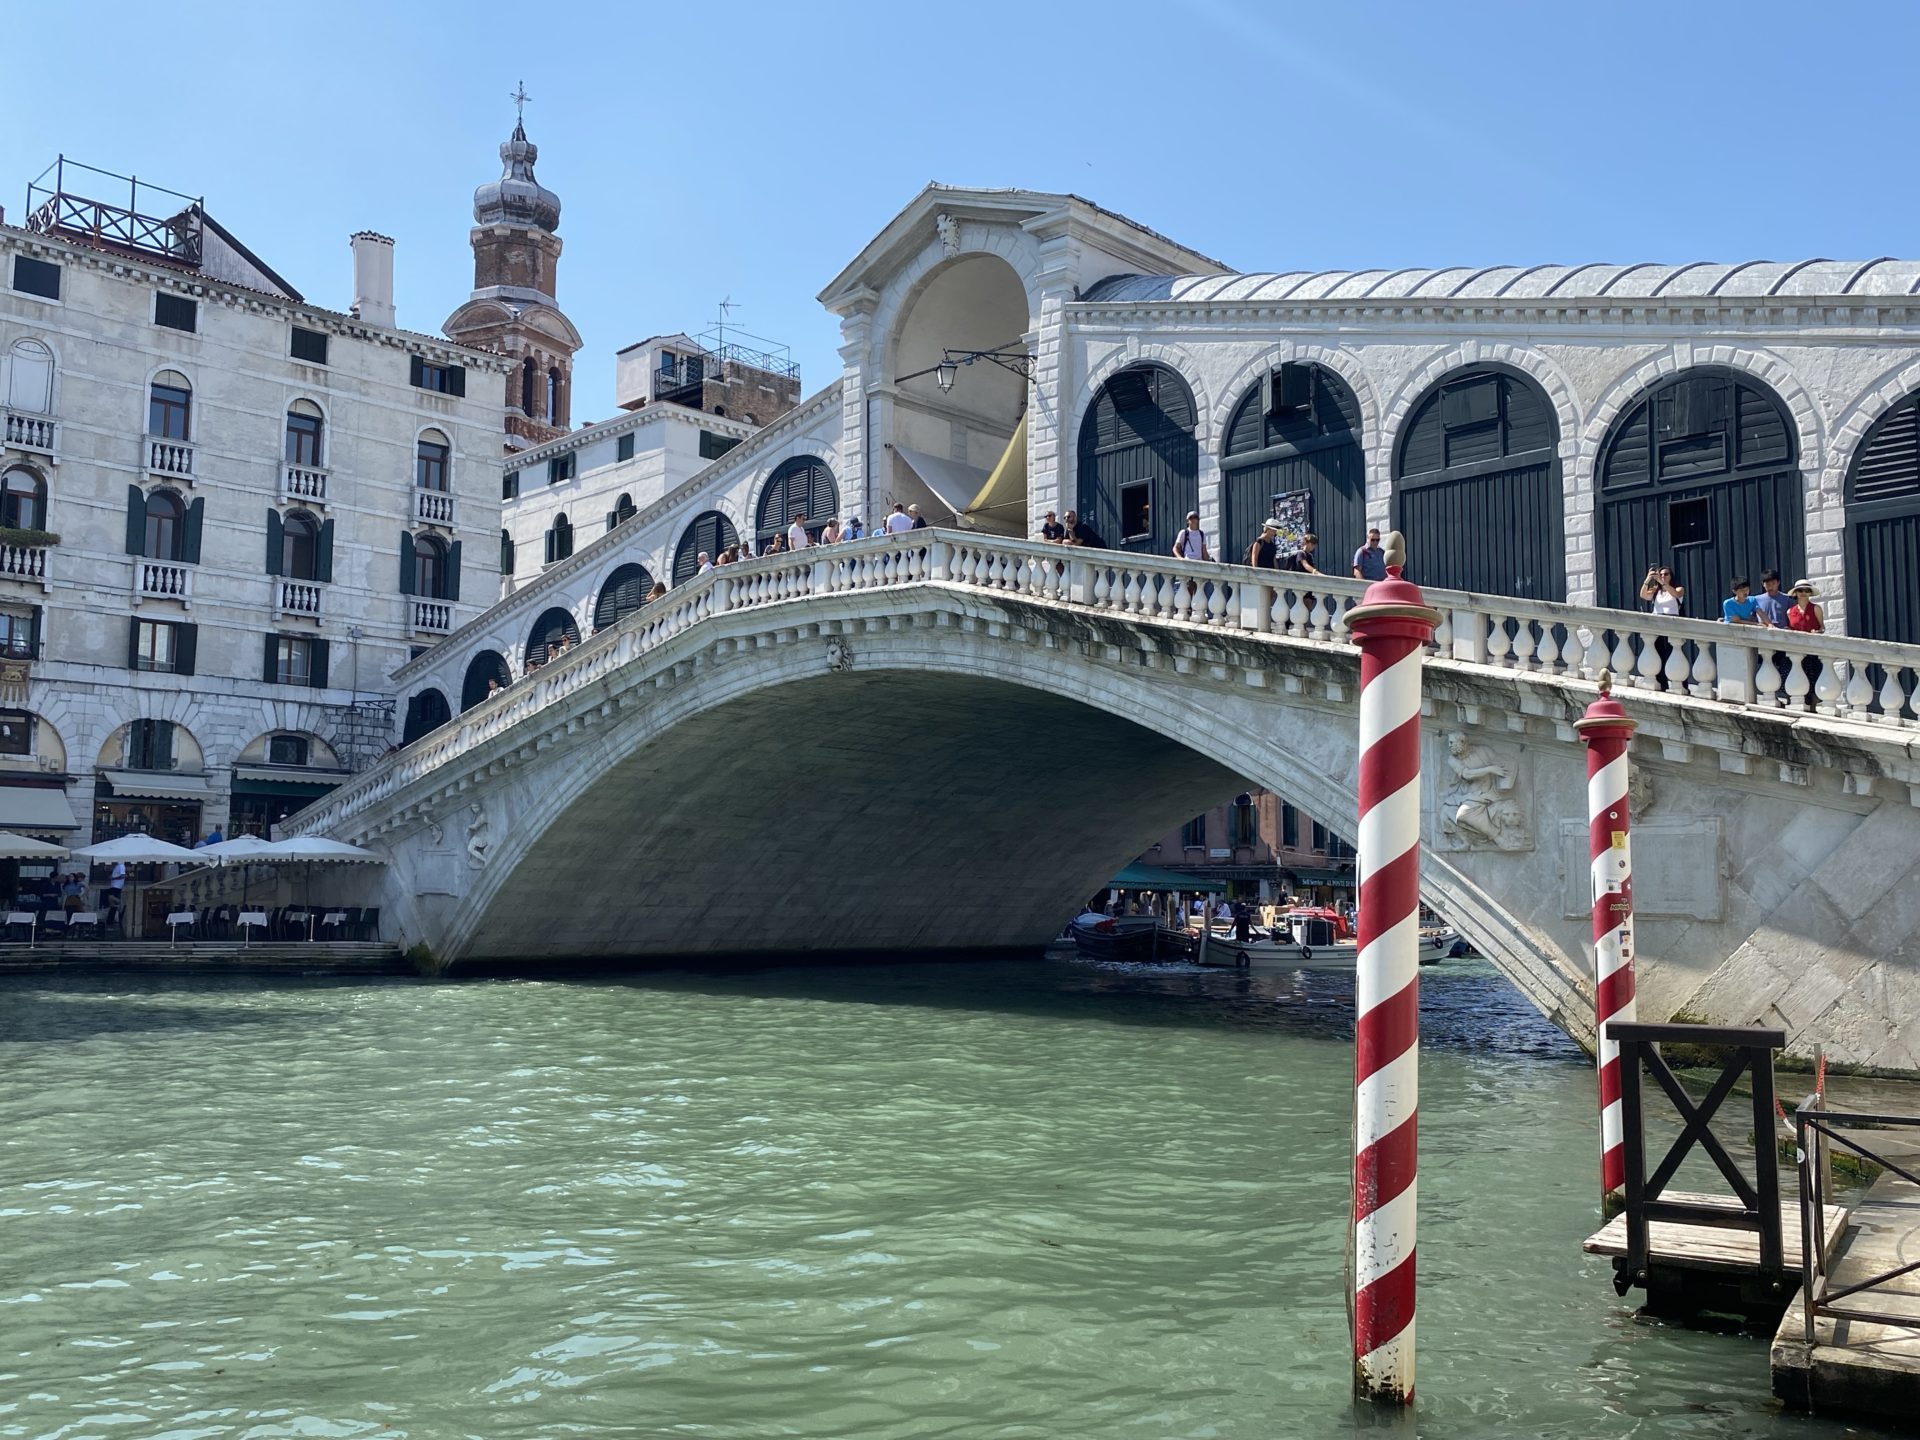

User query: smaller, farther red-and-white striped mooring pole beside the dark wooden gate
[1572,670,1634,1210]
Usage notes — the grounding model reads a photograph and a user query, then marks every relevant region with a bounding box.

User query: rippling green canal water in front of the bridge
[0,962,1889,1440]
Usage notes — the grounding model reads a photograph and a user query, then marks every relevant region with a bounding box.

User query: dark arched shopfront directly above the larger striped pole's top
[1390,365,1567,601]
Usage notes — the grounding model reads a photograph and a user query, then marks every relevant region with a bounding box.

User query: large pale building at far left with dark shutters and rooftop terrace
[0,161,509,845]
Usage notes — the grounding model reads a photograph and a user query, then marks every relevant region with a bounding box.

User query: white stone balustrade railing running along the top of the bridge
[278,530,1920,835]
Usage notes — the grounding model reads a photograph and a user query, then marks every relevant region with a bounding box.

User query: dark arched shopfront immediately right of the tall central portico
[1079,365,1200,555]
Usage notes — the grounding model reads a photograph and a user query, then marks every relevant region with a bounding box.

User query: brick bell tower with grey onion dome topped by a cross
[442,86,580,455]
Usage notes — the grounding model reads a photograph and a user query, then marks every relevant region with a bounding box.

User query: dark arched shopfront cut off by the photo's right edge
[1835,394,1920,645]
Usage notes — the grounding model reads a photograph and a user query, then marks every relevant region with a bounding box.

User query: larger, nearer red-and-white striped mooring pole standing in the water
[1346,532,1440,1405]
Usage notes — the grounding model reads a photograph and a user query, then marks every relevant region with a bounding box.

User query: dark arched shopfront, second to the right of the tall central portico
[1215,365,1367,574]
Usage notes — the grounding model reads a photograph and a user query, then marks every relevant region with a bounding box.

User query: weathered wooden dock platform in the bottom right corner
[1770,1173,1920,1421]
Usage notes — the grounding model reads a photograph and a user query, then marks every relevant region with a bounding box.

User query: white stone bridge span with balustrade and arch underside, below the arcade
[280,530,1920,1071]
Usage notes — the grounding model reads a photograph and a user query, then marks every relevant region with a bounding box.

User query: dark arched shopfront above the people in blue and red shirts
[1596,367,1805,620]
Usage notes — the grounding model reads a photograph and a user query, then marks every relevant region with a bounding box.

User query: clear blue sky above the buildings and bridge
[0,0,1920,420]
